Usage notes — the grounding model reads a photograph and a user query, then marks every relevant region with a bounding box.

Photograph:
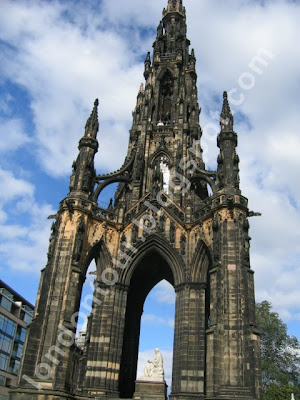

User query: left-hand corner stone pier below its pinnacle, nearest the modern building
[11,212,85,400]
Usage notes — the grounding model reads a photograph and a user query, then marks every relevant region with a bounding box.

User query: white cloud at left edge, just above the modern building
[0,169,54,273]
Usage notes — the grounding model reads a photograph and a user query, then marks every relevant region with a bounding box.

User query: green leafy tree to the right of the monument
[256,301,300,400]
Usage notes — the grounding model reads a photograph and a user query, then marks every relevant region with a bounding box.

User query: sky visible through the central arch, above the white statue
[137,280,175,389]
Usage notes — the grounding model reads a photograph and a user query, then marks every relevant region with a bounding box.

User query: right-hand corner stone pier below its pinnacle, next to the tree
[206,210,260,399]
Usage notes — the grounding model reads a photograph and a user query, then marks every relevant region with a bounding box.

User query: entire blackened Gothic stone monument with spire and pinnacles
[10,0,261,400]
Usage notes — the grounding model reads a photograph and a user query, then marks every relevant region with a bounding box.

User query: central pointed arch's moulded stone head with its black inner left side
[120,234,185,398]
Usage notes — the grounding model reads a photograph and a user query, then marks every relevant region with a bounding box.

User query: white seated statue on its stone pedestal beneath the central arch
[133,348,168,400]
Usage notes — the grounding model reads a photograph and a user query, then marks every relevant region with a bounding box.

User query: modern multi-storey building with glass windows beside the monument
[0,280,34,400]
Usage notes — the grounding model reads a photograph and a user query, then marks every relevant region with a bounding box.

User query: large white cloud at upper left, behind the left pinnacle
[0,1,142,175]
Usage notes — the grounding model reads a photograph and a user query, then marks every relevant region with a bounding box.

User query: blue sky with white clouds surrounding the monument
[0,0,300,388]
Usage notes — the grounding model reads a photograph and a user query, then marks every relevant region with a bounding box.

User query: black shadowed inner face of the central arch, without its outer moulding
[120,250,174,398]
